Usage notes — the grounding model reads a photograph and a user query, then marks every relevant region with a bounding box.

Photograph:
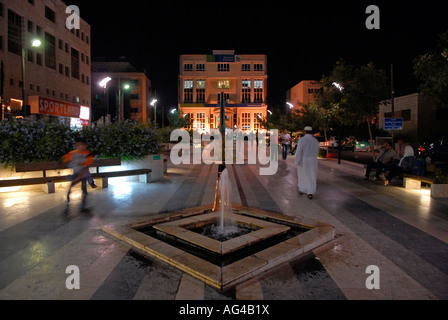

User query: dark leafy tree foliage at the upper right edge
[414,30,448,109]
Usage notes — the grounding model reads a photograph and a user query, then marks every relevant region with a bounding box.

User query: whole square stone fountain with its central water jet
[101,93,335,291]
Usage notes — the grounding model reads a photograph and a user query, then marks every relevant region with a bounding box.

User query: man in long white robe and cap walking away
[295,126,319,199]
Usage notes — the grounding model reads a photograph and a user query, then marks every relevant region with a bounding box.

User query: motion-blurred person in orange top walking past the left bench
[62,139,96,212]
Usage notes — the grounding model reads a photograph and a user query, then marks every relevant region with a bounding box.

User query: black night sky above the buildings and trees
[64,0,448,107]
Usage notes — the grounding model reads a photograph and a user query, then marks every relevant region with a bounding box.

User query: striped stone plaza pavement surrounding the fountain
[0,148,448,301]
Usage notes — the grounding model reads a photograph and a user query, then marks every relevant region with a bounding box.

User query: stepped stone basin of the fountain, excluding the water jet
[101,204,335,291]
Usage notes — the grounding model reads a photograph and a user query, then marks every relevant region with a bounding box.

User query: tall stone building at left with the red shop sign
[0,0,91,124]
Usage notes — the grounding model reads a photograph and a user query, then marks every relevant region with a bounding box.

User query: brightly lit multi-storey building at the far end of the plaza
[178,50,268,133]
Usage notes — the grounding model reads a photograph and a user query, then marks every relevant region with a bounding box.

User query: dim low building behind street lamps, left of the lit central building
[92,61,153,123]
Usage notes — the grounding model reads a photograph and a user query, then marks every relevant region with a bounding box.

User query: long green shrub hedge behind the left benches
[0,119,161,167]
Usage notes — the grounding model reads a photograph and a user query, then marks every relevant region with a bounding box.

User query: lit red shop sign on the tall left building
[28,96,81,118]
